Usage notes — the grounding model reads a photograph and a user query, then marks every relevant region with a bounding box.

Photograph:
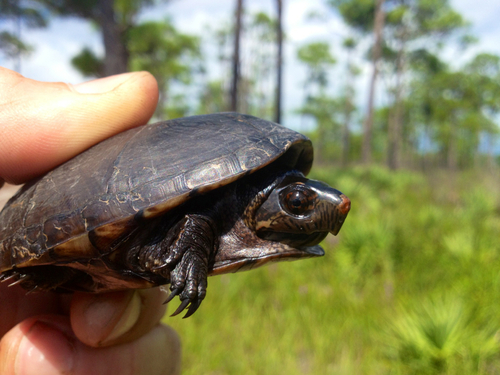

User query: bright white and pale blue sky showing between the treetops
[0,0,500,131]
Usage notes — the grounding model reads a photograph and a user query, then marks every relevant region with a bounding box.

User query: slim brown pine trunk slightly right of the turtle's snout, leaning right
[362,0,385,163]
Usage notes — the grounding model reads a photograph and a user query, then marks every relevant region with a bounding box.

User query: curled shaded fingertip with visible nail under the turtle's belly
[70,288,168,347]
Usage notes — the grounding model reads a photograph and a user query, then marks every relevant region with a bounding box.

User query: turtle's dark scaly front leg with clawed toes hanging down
[141,214,218,318]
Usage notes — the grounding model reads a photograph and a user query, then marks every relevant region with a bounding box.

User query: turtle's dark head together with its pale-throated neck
[211,171,351,275]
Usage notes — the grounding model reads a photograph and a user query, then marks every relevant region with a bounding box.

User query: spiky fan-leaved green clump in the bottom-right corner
[387,297,500,374]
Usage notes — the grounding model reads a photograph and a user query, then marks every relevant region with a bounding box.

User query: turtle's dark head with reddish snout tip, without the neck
[254,175,351,248]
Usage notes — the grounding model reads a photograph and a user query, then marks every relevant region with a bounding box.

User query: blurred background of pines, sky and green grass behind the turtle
[0,0,500,374]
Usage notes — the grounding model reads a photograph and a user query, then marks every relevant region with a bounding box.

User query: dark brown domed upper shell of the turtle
[0,113,313,272]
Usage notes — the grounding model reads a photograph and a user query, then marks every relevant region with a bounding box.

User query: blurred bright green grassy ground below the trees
[164,168,500,375]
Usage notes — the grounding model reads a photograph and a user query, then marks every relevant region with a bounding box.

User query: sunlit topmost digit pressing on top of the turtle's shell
[0,68,158,183]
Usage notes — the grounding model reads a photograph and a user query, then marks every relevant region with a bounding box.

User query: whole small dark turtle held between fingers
[0,112,350,317]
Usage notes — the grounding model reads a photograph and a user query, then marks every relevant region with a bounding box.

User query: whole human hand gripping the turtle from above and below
[0,67,180,375]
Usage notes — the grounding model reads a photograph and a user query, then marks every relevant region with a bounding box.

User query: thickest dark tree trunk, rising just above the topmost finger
[98,0,129,76]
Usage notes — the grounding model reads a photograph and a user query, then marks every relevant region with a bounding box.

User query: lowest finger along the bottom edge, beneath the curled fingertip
[0,316,180,375]
